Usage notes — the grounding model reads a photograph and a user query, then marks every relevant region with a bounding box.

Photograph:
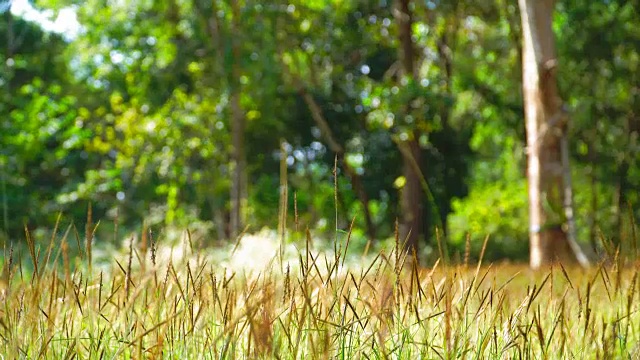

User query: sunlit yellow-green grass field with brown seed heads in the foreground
[0,226,640,359]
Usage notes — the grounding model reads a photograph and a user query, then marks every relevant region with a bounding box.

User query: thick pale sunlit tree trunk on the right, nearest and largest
[519,0,576,269]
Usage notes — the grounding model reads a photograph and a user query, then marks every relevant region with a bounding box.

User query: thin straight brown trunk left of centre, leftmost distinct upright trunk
[230,0,247,237]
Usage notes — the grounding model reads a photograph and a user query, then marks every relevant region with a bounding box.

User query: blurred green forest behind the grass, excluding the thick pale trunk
[0,0,640,260]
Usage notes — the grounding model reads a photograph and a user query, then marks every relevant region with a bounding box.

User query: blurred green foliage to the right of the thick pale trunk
[556,0,640,255]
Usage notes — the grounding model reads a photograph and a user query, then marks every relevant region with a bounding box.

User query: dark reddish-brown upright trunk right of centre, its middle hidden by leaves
[393,0,422,250]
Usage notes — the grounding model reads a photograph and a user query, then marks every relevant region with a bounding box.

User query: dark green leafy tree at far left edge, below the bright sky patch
[0,6,91,241]
